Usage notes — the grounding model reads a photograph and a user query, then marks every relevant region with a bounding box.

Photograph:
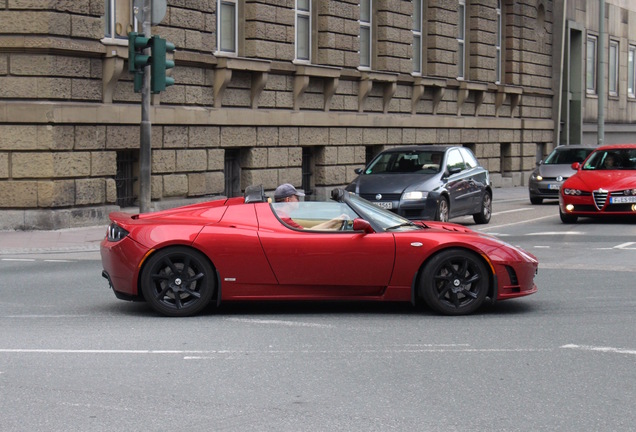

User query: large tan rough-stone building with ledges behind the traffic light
[0,0,555,229]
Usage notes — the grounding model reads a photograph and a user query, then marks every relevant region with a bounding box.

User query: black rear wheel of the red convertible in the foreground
[141,247,216,317]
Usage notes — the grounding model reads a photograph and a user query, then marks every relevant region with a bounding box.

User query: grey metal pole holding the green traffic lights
[139,0,152,213]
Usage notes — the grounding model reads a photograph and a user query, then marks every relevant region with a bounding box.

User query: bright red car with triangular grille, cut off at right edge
[559,144,636,223]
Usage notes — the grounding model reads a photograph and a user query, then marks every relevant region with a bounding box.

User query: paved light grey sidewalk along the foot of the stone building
[0,186,528,257]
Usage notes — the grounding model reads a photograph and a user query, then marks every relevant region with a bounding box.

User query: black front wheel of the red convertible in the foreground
[419,249,490,315]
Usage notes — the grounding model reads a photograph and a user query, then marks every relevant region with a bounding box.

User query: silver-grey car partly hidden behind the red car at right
[528,145,594,204]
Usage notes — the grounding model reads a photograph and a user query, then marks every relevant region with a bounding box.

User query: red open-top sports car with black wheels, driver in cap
[101,187,538,316]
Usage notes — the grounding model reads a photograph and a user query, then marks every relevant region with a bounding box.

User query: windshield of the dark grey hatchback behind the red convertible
[364,150,444,175]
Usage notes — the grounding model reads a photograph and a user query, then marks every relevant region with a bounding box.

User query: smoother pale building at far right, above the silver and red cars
[553,0,636,145]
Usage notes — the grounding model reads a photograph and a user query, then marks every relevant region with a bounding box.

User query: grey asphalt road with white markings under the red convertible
[0,194,636,431]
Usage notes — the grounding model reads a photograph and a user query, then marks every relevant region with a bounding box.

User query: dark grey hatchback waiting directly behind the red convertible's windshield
[347,145,492,224]
